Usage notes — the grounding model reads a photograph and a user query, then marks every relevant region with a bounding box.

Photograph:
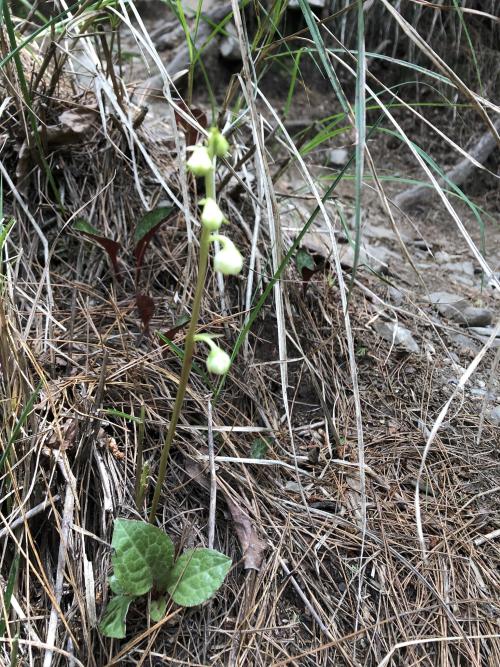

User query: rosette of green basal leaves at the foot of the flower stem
[99,519,232,639]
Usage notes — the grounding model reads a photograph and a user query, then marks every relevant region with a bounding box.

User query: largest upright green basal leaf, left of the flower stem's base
[111,519,174,596]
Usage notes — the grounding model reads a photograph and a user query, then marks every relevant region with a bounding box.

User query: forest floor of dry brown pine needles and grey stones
[0,5,500,667]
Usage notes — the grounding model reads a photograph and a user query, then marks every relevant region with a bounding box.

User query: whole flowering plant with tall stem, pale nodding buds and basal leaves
[99,129,243,639]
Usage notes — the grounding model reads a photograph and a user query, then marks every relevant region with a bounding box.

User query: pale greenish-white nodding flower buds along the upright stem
[186,128,243,375]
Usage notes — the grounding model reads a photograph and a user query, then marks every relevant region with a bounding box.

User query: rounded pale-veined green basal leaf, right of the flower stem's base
[168,549,232,607]
